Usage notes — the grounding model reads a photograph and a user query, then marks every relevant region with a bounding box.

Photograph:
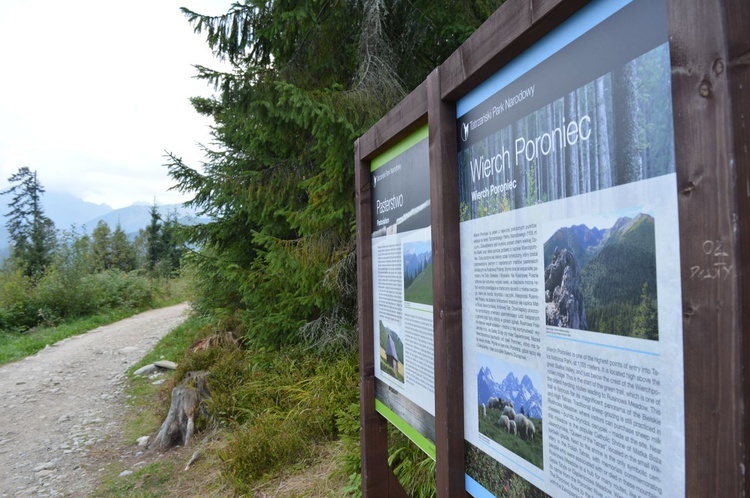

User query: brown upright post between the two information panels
[427,69,466,498]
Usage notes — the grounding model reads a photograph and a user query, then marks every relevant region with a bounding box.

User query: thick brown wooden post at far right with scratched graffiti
[667,0,747,497]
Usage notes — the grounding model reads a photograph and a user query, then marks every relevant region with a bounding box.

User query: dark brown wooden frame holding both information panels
[355,0,750,497]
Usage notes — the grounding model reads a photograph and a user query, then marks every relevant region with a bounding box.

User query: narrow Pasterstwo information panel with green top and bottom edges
[371,126,435,459]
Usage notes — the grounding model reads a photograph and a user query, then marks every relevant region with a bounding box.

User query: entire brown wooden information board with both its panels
[355,0,750,497]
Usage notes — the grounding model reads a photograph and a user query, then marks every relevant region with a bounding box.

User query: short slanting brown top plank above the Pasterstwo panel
[359,82,427,161]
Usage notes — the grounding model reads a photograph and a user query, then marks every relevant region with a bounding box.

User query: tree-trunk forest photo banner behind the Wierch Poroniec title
[458,44,675,221]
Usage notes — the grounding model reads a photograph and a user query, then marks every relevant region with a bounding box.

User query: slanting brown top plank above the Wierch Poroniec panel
[440,0,588,101]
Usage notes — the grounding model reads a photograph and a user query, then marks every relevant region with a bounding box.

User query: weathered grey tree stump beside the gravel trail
[149,371,211,450]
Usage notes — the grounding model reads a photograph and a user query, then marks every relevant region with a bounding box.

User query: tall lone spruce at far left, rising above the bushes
[0,166,57,277]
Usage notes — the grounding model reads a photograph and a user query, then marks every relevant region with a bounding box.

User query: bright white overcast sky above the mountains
[0,0,232,208]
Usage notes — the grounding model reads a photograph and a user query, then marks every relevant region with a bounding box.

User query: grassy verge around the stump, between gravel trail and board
[94,318,368,498]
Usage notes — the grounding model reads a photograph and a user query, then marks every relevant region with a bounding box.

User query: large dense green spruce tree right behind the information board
[168,0,501,346]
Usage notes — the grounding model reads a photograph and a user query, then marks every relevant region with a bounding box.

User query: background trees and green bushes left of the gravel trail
[0,167,184,332]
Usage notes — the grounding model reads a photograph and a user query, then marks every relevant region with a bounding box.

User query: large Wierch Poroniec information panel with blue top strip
[457,0,685,497]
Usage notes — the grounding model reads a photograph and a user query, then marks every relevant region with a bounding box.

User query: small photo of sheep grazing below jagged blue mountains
[477,355,544,469]
